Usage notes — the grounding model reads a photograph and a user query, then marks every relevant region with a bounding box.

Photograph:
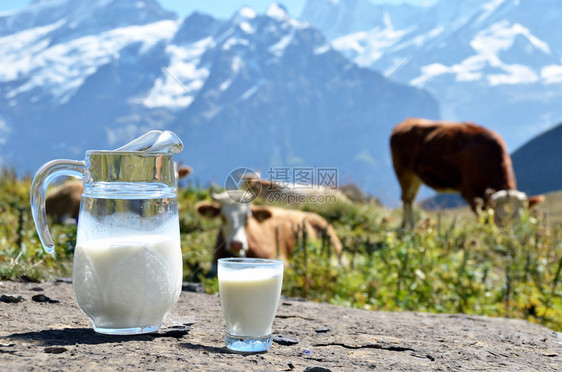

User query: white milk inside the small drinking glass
[218,268,283,337]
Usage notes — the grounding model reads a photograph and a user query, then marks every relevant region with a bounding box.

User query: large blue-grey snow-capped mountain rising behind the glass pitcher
[0,0,439,200]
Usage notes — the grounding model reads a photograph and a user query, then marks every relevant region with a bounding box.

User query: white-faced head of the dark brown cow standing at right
[487,190,544,226]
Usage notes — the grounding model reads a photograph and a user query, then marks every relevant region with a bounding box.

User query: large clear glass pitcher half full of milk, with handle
[31,131,183,334]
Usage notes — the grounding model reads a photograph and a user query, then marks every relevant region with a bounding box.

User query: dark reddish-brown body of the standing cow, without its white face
[390,118,544,227]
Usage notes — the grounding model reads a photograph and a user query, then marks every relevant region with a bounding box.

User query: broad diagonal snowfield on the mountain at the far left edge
[0,21,178,104]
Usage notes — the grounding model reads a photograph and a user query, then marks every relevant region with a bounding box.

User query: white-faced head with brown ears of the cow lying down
[196,191,271,257]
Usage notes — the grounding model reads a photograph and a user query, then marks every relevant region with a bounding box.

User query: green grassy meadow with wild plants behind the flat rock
[0,169,562,331]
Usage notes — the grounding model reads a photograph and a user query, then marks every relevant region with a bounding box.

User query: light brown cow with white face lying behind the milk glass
[196,191,342,262]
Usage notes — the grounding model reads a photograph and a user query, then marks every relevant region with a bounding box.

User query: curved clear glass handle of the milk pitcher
[30,159,86,253]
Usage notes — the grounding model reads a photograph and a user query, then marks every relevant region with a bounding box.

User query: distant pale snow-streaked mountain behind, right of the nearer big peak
[301,0,562,150]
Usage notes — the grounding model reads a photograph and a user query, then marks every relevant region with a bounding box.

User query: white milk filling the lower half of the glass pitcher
[73,235,182,329]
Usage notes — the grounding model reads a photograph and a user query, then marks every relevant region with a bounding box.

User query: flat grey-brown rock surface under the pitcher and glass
[0,282,562,371]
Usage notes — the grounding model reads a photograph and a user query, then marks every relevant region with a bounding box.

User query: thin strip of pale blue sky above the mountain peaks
[0,0,435,18]
